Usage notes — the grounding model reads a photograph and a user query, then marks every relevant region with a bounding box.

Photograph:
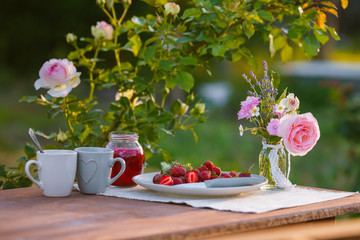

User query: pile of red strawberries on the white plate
[153,161,250,185]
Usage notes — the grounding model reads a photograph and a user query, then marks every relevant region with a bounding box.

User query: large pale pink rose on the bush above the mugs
[34,59,81,97]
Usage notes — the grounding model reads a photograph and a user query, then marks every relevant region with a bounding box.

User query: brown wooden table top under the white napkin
[0,187,360,240]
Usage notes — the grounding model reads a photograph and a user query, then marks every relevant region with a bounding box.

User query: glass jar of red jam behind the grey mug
[106,131,145,186]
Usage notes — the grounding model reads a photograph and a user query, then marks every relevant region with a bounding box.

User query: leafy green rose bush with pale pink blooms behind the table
[16,0,346,177]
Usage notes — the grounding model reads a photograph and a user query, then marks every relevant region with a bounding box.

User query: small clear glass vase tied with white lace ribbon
[259,139,292,190]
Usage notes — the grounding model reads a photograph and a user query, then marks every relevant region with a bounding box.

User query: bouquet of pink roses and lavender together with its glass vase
[238,61,320,189]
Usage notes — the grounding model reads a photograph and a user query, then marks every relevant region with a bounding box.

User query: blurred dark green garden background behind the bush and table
[0,0,360,191]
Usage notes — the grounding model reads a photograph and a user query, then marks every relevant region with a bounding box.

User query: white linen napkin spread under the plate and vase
[75,186,356,213]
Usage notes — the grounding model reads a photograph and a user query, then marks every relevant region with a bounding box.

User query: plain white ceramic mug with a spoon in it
[25,150,77,197]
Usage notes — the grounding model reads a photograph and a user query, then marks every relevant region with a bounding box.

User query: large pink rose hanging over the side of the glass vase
[278,113,320,156]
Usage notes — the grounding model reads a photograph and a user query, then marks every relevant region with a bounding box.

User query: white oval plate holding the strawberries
[133,172,267,197]
